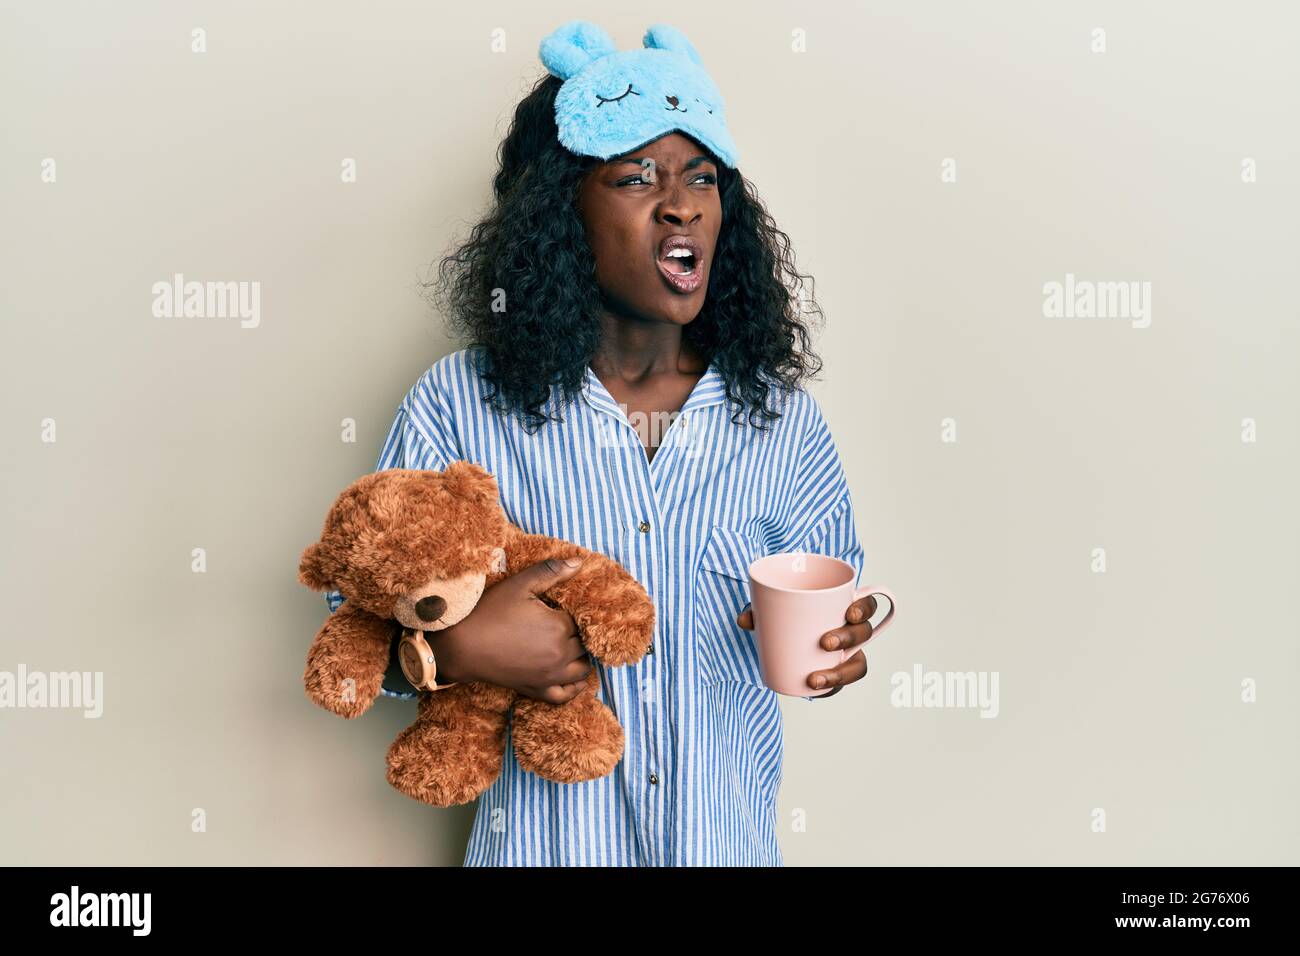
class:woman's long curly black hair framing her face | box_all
[421,73,823,431]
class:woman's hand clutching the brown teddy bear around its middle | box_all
[425,558,592,704]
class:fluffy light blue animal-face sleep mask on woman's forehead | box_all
[538,20,737,169]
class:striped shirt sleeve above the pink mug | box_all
[781,395,865,700]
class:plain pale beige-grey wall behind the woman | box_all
[0,3,1300,865]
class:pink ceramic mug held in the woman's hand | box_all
[749,551,896,697]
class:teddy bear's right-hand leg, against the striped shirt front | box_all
[511,667,623,783]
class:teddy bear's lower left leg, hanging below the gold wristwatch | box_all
[387,684,514,806]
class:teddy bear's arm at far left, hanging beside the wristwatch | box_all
[303,601,395,718]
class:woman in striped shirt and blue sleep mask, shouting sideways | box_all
[332,23,875,865]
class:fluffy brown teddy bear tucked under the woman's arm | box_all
[298,460,655,806]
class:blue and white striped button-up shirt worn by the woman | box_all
[328,350,863,866]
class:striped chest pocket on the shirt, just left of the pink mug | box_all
[694,524,764,687]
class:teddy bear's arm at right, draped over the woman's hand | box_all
[506,527,654,666]
